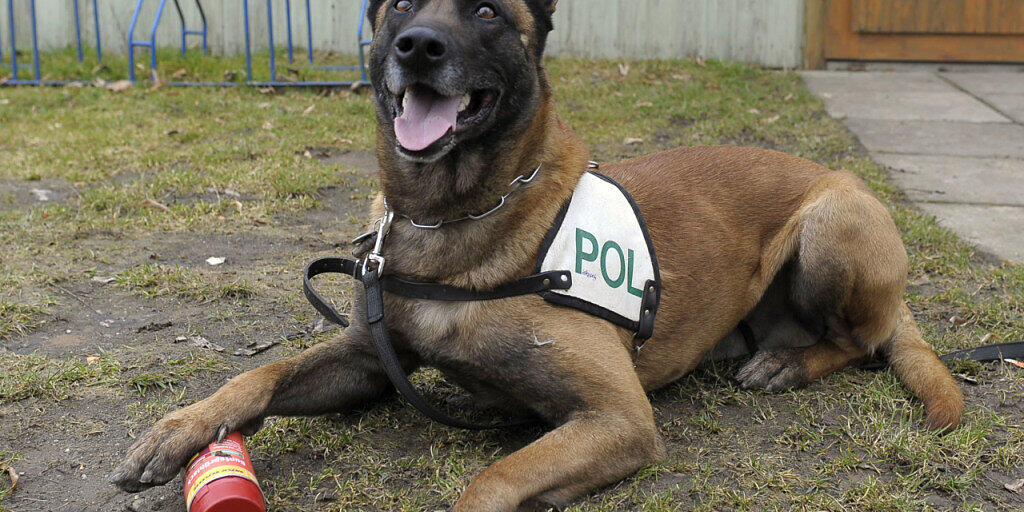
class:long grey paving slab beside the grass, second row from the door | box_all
[824,91,1007,123]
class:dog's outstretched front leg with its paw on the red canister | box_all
[110,328,399,493]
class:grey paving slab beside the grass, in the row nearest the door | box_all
[800,71,957,94]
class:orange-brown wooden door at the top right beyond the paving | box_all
[805,0,1024,67]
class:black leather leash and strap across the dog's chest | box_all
[302,258,572,430]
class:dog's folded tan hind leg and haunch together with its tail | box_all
[737,172,963,428]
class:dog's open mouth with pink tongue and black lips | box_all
[394,84,498,154]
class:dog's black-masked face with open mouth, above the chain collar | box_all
[367,0,557,163]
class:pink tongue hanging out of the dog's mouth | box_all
[394,87,462,152]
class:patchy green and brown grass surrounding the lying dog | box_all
[0,51,1024,512]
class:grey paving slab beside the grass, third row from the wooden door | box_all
[846,119,1024,159]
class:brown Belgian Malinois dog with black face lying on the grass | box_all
[112,0,963,512]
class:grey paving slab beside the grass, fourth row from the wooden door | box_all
[871,153,1024,207]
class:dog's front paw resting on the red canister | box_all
[109,406,222,493]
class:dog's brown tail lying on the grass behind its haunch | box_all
[888,304,964,432]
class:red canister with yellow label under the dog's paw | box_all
[185,432,266,512]
